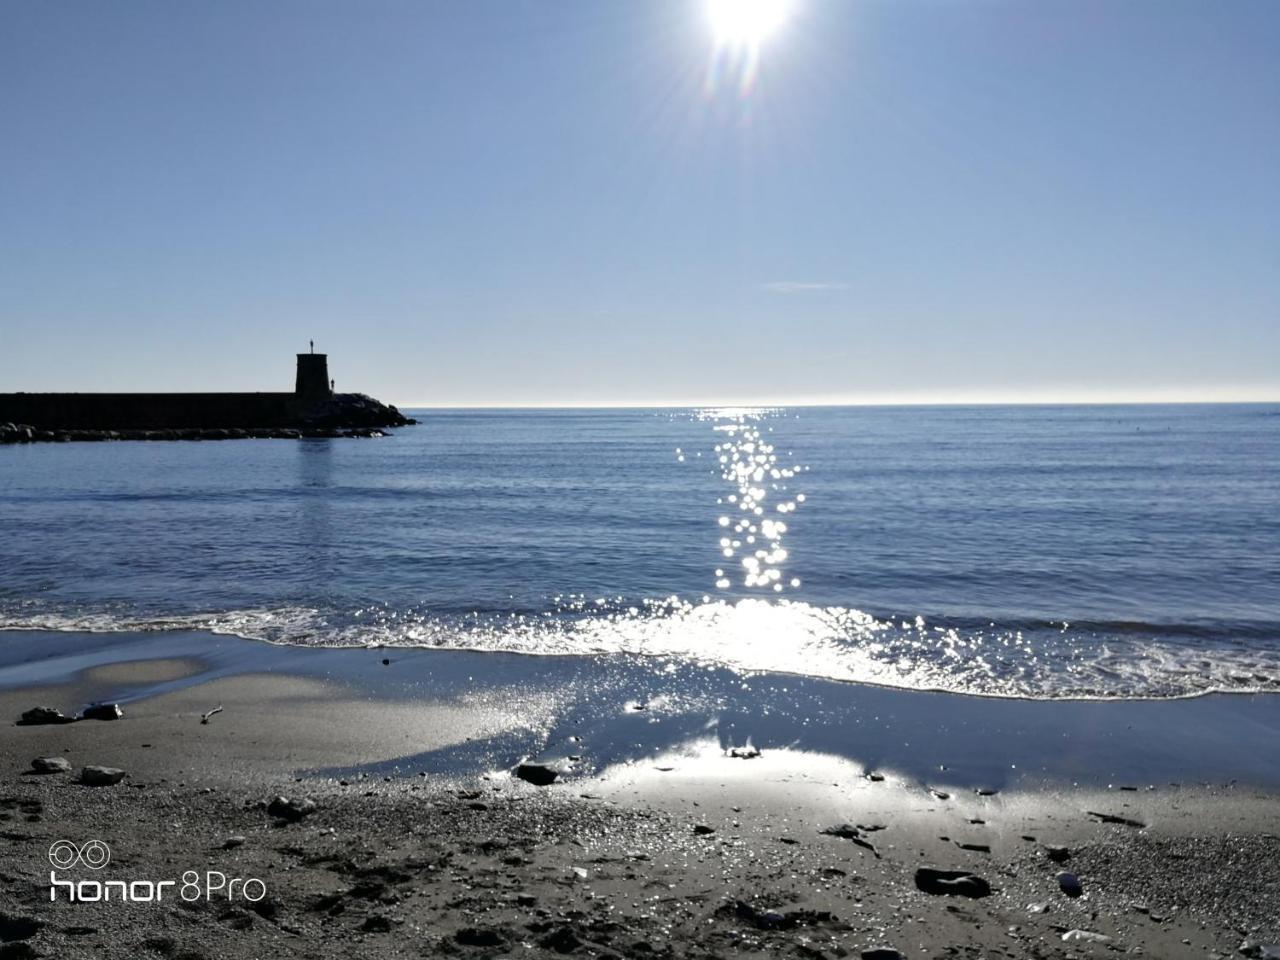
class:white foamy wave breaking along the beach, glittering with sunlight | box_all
[0,598,1280,699]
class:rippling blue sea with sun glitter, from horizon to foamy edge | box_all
[0,404,1280,698]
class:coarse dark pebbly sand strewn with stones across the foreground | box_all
[0,776,1280,960]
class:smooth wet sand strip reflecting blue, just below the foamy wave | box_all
[0,631,1280,790]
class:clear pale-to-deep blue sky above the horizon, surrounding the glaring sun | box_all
[0,0,1280,406]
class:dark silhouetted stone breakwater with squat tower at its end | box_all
[0,353,417,443]
